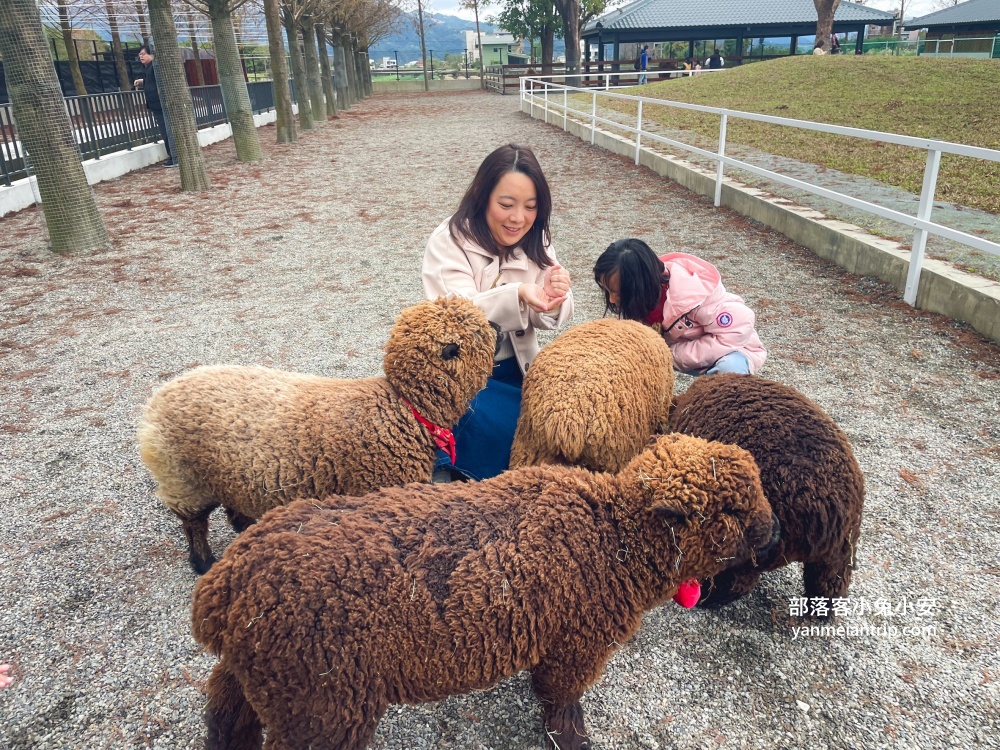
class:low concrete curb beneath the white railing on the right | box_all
[521,95,1000,343]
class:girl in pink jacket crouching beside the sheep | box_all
[594,239,767,375]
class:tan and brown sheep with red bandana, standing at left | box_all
[139,298,496,573]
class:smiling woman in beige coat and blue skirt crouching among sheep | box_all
[423,144,573,479]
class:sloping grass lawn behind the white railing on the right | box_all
[601,55,1000,214]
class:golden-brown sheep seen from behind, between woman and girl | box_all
[510,318,674,472]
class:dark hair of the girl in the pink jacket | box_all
[594,238,664,321]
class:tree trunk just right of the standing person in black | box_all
[149,0,211,192]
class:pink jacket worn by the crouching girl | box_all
[660,253,767,373]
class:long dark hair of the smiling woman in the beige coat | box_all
[448,143,552,268]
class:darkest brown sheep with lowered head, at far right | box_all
[668,375,865,606]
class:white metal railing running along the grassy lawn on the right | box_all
[521,74,1000,305]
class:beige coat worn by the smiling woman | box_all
[423,217,573,372]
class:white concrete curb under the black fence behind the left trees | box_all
[0,110,282,216]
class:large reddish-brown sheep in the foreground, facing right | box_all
[192,435,773,750]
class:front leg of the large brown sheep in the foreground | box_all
[531,659,592,750]
